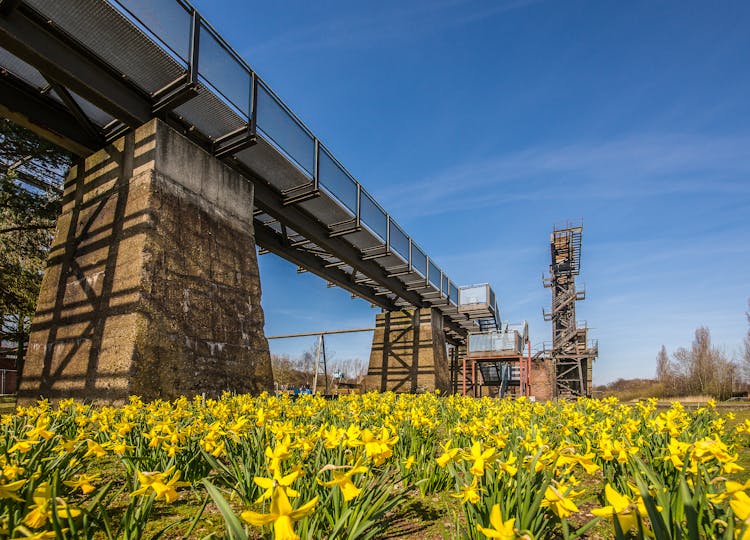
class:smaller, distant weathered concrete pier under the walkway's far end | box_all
[365,308,450,393]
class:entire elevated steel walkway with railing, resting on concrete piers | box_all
[0,0,506,343]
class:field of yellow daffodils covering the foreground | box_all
[0,393,750,540]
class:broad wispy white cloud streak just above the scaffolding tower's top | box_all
[380,134,750,216]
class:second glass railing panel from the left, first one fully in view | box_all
[198,25,251,117]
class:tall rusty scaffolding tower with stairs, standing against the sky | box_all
[543,226,599,399]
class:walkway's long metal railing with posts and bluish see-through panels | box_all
[107,0,464,306]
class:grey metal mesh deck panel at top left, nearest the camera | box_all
[28,0,184,93]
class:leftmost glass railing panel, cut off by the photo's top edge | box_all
[117,0,191,62]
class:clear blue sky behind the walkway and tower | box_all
[195,0,750,384]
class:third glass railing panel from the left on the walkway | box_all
[257,84,315,176]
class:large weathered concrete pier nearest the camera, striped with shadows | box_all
[19,120,273,402]
